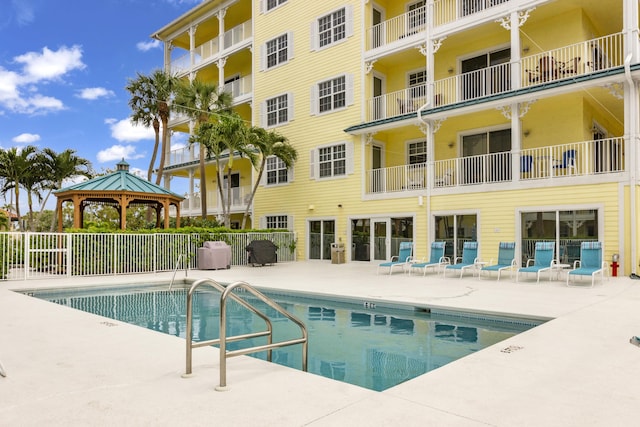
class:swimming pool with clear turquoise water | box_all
[27,285,541,391]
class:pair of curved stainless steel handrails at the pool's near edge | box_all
[184,279,309,391]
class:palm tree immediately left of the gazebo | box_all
[42,148,93,231]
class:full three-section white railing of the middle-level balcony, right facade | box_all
[366,33,624,122]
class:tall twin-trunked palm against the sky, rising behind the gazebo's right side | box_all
[126,69,178,185]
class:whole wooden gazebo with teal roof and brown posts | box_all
[54,159,184,232]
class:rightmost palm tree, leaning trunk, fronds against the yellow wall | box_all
[242,127,298,229]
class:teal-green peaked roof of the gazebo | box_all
[56,160,184,200]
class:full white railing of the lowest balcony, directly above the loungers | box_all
[365,138,625,194]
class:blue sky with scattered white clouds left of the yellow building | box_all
[0,0,201,209]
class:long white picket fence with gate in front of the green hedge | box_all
[0,232,296,280]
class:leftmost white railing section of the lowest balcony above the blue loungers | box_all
[366,163,427,194]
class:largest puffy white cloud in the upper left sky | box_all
[13,45,86,82]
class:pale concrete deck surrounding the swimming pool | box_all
[0,261,640,427]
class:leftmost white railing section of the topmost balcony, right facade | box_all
[366,6,427,50]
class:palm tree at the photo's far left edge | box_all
[0,145,37,229]
